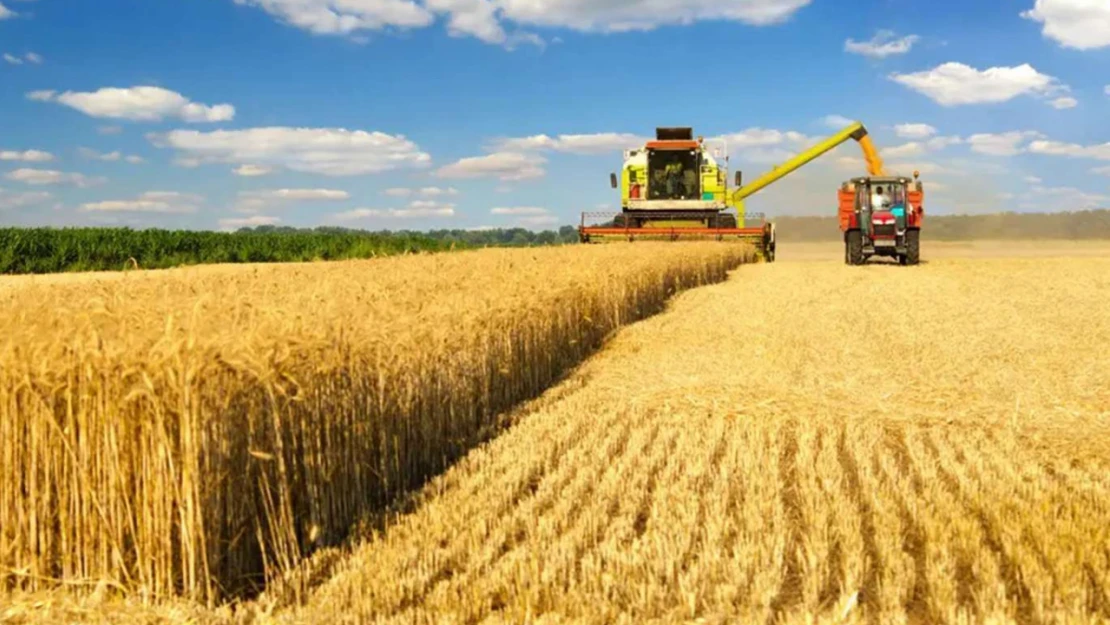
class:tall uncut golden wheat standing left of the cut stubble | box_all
[0,244,750,602]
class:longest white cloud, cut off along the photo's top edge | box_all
[235,0,811,47]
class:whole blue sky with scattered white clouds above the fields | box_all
[0,0,1110,229]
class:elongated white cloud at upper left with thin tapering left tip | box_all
[27,87,235,122]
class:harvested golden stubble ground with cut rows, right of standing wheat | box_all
[0,245,1110,625]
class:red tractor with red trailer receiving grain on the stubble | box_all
[838,171,925,264]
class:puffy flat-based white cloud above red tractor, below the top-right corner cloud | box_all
[889,62,1067,107]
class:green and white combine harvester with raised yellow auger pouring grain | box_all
[578,122,882,262]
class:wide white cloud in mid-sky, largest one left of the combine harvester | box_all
[154,127,432,177]
